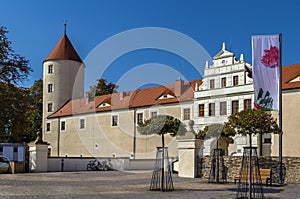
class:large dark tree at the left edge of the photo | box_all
[0,26,31,142]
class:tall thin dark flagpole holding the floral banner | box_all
[278,33,284,184]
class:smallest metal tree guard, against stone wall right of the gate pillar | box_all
[208,148,226,183]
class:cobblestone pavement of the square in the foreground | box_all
[0,171,300,199]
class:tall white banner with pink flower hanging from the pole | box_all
[252,35,280,110]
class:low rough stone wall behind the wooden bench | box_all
[198,156,300,183]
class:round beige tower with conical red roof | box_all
[43,27,85,140]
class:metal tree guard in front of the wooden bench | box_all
[236,147,264,199]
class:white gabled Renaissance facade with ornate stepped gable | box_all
[194,43,272,156]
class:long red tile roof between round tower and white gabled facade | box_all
[48,80,202,118]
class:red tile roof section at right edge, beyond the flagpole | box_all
[282,64,300,90]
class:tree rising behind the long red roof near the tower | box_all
[87,78,119,99]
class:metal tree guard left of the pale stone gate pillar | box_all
[150,147,174,191]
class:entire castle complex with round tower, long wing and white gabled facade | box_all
[43,28,300,159]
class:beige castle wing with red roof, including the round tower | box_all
[43,29,197,158]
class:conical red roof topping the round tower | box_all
[44,34,82,63]
